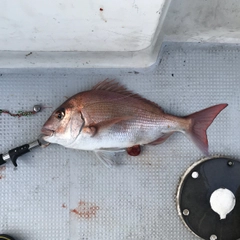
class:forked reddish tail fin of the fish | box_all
[185,104,228,155]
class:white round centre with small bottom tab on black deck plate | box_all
[210,188,236,220]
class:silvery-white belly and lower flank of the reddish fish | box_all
[66,118,178,150]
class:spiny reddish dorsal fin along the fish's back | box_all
[92,78,163,111]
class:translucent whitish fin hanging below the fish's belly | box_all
[94,150,124,168]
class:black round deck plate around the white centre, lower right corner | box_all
[177,157,240,240]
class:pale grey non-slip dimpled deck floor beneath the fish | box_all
[0,43,237,240]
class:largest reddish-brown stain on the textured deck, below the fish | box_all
[71,201,99,219]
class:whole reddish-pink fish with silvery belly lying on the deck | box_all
[41,79,228,167]
